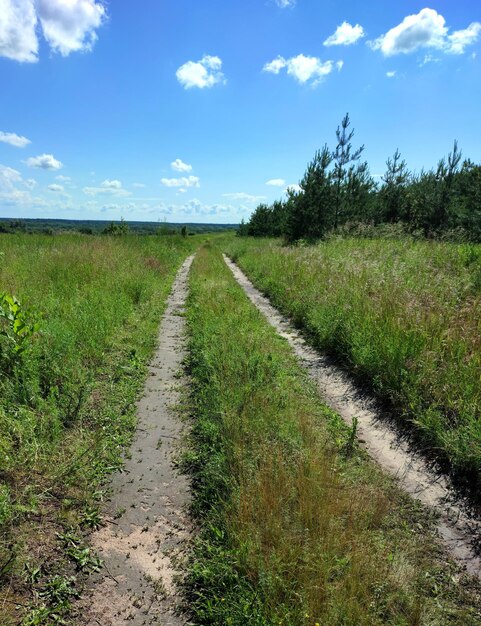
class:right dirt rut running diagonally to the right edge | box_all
[224,255,481,578]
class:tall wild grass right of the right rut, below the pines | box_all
[225,237,481,494]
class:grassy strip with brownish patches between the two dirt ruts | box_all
[185,245,481,626]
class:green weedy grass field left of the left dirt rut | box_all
[0,235,197,626]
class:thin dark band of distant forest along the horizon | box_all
[0,217,237,235]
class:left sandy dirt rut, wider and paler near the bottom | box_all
[79,257,193,626]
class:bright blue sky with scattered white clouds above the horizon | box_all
[0,0,481,223]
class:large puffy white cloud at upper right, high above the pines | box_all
[368,9,481,56]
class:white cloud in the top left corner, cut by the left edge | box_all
[0,0,38,63]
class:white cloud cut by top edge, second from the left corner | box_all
[37,0,106,56]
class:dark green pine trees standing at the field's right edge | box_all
[238,114,481,242]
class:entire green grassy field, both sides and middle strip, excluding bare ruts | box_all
[0,234,481,626]
